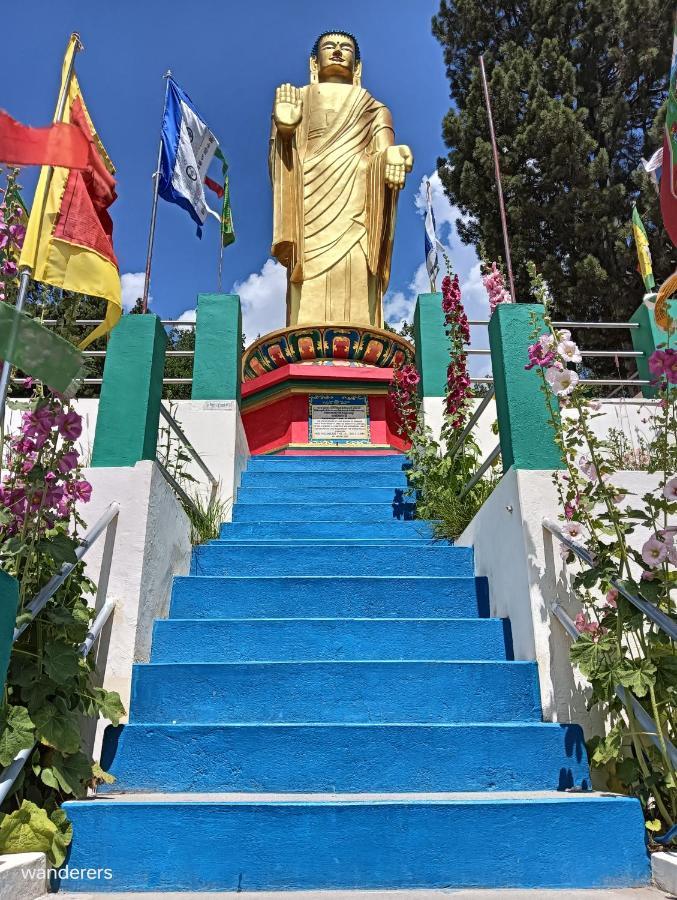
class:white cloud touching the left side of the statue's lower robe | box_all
[233,259,287,344]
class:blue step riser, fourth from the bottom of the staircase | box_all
[151,618,511,663]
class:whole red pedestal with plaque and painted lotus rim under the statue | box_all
[242,325,413,454]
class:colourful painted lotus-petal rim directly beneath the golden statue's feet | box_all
[242,325,414,381]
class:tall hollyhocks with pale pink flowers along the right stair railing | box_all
[525,292,677,833]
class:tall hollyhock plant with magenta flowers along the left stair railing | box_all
[0,396,124,864]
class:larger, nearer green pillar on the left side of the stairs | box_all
[92,313,167,466]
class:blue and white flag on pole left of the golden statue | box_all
[158,76,219,237]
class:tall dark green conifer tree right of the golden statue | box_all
[433,0,676,330]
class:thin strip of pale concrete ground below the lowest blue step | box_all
[51,887,672,900]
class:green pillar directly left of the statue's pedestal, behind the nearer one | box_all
[191,294,242,403]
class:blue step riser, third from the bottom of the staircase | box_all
[130,661,541,723]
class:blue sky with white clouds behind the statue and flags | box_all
[0,0,486,350]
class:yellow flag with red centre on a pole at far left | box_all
[19,35,122,348]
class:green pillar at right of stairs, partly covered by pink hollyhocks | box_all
[489,303,563,472]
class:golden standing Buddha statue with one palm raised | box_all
[270,32,413,328]
